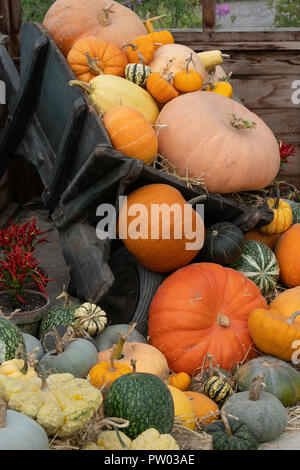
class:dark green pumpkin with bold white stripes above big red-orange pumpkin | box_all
[231,240,279,295]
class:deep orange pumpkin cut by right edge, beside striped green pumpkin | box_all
[275,224,300,287]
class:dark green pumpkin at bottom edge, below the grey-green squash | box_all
[203,418,258,450]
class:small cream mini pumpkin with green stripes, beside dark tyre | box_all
[73,302,107,336]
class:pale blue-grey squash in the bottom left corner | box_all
[0,410,49,450]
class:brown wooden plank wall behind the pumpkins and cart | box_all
[0,0,300,199]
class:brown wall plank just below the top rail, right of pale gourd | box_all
[224,50,300,77]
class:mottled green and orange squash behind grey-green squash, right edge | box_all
[234,356,300,406]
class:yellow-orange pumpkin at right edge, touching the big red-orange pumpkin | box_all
[248,308,300,361]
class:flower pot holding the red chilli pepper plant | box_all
[0,289,50,336]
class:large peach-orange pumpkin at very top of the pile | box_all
[43,0,147,57]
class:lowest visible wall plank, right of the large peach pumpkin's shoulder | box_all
[251,108,300,145]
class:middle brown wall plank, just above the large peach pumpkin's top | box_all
[231,75,300,109]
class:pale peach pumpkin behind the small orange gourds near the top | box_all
[148,44,207,83]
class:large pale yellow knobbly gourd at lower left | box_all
[0,374,103,437]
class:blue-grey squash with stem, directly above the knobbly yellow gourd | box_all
[36,338,98,378]
